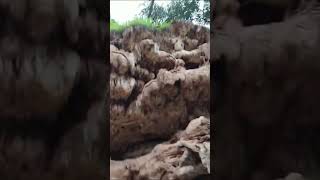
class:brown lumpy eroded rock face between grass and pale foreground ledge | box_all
[110,22,210,179]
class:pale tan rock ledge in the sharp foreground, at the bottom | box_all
[110,116,210,180]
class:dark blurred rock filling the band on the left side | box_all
[0,0,107,179]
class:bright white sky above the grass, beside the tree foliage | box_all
[110,0,169,23]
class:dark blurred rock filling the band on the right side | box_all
[211,1,320,180]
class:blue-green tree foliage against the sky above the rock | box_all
[140,0,210,24]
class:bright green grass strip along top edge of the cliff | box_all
[110,18,171,32]
